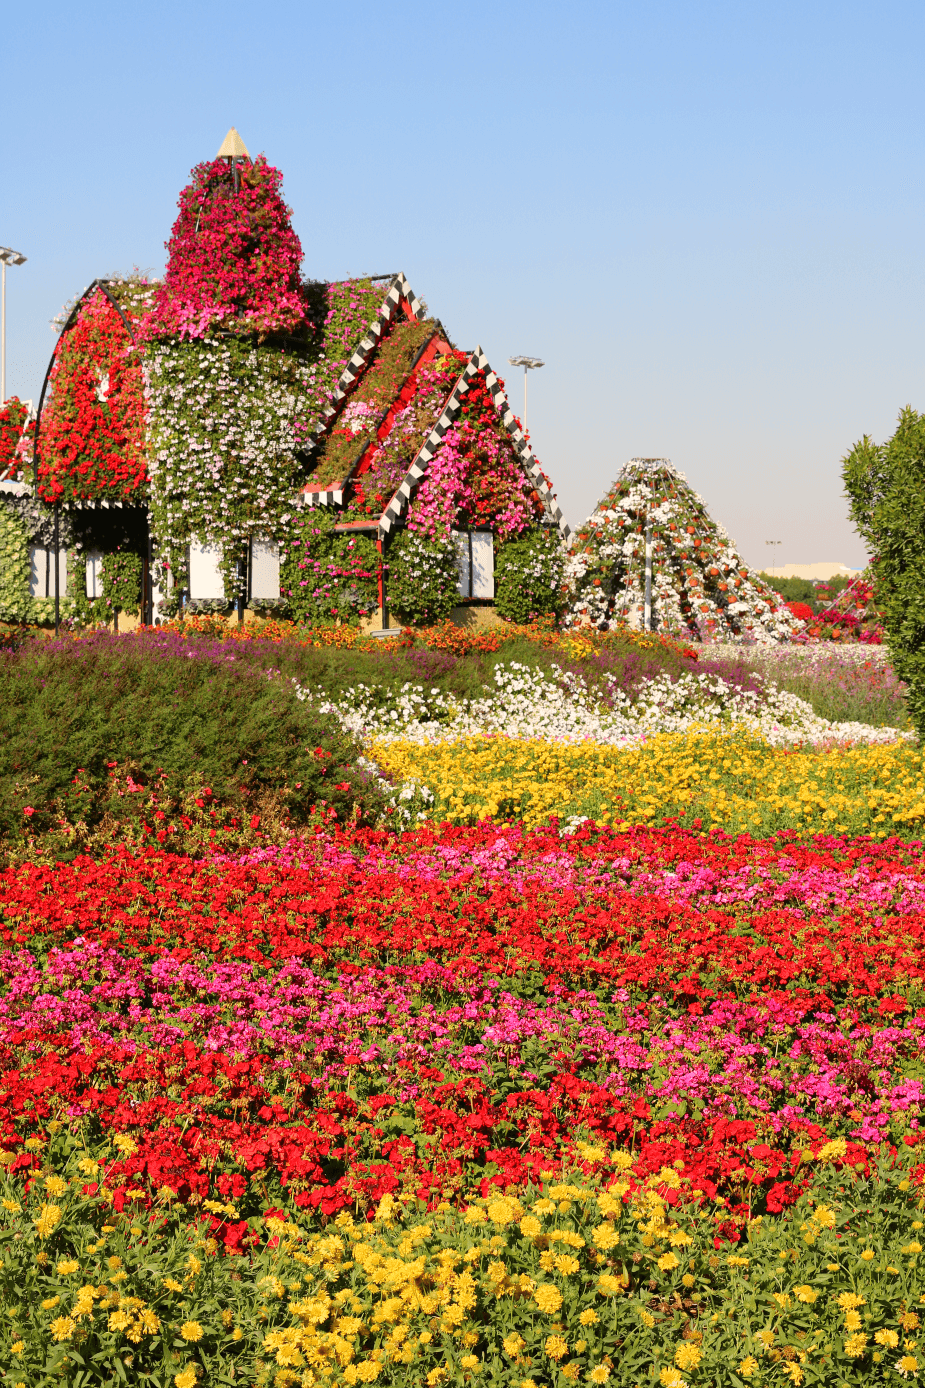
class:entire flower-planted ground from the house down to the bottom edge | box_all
[0,625,925,1388]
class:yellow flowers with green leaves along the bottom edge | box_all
[0,1138,925,1388]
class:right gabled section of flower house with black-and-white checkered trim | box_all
[290,275,568,620]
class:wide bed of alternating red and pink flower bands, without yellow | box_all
[0,827,925,1238]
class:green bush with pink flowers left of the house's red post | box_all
[279,507,379,626]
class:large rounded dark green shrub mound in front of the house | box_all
[0,633,378,847]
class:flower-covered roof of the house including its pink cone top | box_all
[35,130,567,545]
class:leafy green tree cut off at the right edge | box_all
[842,405,925,740]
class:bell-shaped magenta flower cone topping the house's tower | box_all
[144,144,304,339]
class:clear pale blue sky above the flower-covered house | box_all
[0,0,925,566]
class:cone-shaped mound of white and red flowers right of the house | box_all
[565,458,803,641]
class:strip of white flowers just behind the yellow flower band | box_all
[296,662,911,747]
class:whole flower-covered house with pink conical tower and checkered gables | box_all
[16,130,567,625]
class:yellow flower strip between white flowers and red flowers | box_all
[372,731,925,838]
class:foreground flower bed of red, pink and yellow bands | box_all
[0,826,925,1388]
